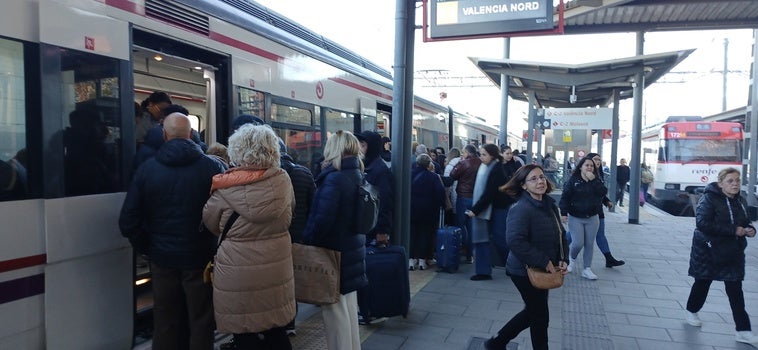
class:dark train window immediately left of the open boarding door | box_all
[53,49,122,196]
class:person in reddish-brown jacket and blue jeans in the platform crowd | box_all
[450,145,482,263]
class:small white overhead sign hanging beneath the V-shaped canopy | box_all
[545,108,613,129]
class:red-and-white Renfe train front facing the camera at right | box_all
[643,121,743,214]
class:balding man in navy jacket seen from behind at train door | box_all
[119,113,223,350]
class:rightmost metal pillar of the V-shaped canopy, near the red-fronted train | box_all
[629,32,645,224]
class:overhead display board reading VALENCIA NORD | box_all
[430,0,553,39]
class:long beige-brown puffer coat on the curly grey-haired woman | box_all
[203,168,295,333]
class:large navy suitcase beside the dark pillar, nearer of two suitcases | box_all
[358,246,411,319]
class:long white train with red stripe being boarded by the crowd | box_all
[0,0,504,349]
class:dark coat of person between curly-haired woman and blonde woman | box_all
[280,153,316,242]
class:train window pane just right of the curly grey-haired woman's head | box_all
[274,127,322,174]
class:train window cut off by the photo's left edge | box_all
[0,39,29,201]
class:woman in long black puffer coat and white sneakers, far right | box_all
[686,168,758,344]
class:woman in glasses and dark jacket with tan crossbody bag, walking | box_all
[485,164,568,350]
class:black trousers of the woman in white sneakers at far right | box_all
[687,279,751,332]
